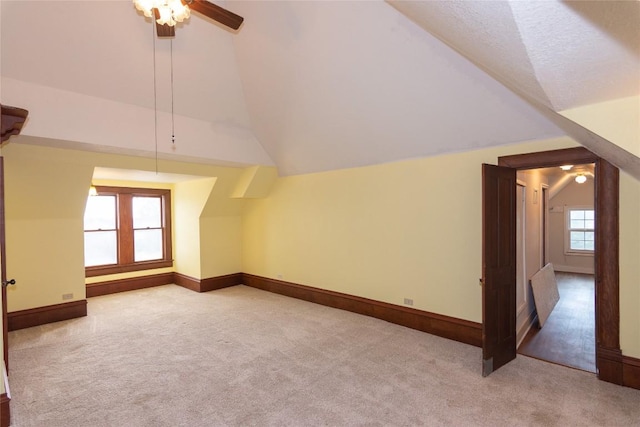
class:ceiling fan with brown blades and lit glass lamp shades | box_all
[133,0,244,37]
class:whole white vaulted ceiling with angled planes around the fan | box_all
[0,0,640,178]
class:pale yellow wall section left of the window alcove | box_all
[2,143,93,312]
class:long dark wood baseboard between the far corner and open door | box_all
[242,273,482,347]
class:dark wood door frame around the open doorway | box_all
[483,147,622,384]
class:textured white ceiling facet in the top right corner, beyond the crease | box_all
[510,1,640,111]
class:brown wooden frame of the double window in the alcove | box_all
[83,186,173,277]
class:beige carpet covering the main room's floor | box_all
[9,285,640,427]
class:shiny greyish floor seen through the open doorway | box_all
[518,273,596,372]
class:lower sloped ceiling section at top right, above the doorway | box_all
[388,0,640,179]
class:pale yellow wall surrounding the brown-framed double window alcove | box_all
[2,140,244,312]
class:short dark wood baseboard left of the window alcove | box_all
[7,299,87,331]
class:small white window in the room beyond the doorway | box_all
[565,206,595,255]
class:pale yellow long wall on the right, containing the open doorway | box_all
[242,139,640,357]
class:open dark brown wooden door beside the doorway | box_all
[482,164,516,376]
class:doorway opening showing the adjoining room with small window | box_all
[516,164,596,373]
